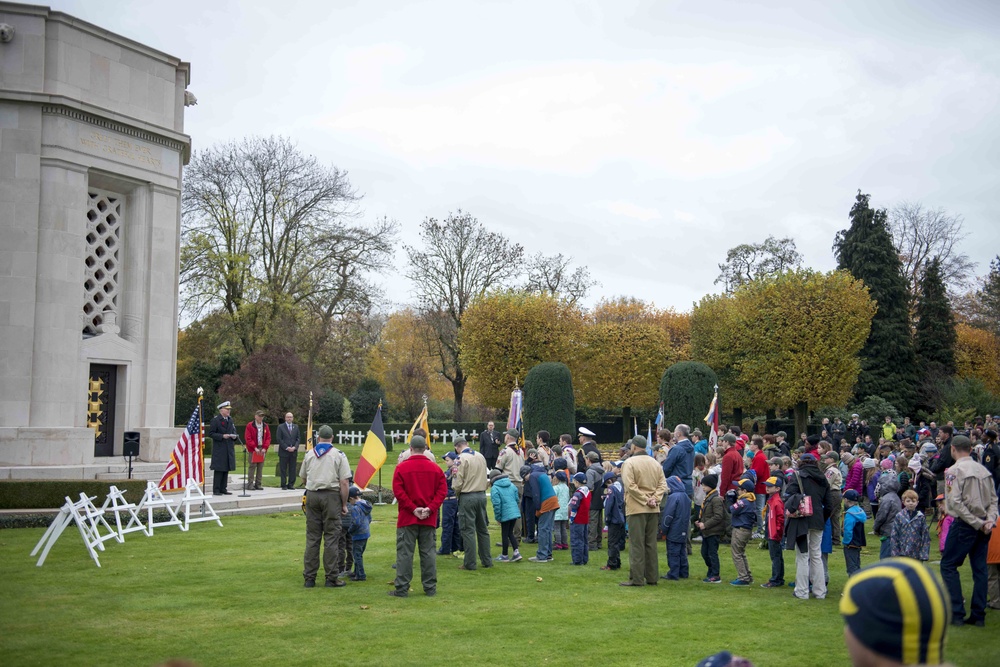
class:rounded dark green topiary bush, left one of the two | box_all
[523,361,576,444]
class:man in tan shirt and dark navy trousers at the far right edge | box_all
[941,435,997,627]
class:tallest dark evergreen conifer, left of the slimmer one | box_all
[833,190,916,414]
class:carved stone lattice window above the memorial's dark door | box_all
[83,190,124,336]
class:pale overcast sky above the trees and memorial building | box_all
[53,0,1000,310]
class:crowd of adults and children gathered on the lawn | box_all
[211,396,1000,666]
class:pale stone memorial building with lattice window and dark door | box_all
[0,2,193,477]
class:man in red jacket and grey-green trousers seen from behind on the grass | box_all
[389,435,448,598]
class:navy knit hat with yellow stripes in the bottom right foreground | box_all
[840,558,951,665]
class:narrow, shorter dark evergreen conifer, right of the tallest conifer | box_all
[913,257,958,409]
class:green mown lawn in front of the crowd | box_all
[0,448,1000,667]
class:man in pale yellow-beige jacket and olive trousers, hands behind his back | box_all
[618,435,667,586]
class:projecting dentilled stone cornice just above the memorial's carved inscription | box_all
[0,90,191,164]
